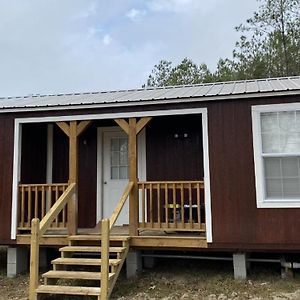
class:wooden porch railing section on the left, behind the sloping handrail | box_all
[18,183,68,230]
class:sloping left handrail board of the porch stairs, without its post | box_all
[40,183,76,236]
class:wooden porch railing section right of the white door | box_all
[138,181,205,231]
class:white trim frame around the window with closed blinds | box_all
[252,103,300,208]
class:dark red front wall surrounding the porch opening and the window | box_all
[0,96,300,250]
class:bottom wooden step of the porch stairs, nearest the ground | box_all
[36,285,101,296]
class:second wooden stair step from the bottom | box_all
[42,271,114,280]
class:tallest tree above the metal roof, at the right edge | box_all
[233,0,300,79]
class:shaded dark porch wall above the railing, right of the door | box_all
[146,115,203,181]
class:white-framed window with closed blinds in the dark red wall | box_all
[252,104,300,207]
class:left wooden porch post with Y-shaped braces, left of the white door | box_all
[56,121,91,235]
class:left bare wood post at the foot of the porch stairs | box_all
[29,219,40,300]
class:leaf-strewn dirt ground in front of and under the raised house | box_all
[0,248,300,300]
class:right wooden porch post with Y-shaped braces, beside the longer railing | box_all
[115,117,152,236]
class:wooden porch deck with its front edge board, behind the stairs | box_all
[17,225,207,249]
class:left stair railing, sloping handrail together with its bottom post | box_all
[29,183,76,300]
